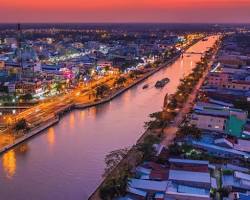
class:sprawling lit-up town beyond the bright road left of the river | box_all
[0,28,188,101]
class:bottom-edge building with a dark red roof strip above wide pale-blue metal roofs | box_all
[166,158,212,200]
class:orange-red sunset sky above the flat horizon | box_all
[0,0,250,23]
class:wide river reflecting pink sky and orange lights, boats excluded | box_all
[0,36,219,200]
